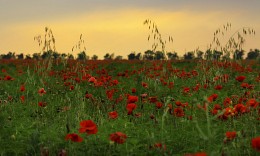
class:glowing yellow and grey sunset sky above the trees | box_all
[0,0,260,59]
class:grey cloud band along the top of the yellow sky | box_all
[0,0,260,23]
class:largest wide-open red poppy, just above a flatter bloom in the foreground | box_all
[79,120,98,135]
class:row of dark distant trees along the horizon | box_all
[0,49,260,60]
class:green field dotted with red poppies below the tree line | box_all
[0,59,260,156]
